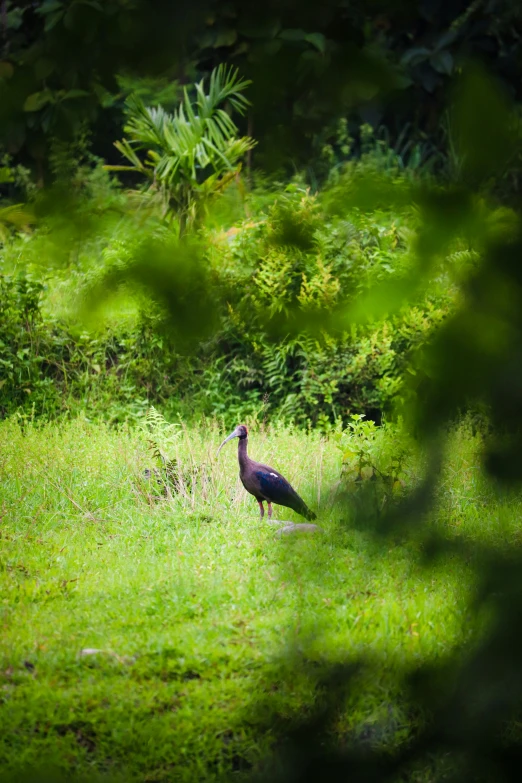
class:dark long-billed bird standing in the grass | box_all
[218,424,316,519]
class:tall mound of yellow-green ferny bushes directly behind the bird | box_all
[191,182,454,425]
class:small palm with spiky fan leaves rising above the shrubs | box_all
[106,65,255,235]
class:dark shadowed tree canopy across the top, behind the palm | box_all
[0,0,522,178]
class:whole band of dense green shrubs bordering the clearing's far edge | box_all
[0,177,451,426]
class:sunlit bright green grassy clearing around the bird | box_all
[0,420,520,781]
